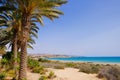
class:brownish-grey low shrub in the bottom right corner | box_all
[98,66,120,80]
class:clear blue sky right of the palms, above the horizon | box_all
[28,0,120,56]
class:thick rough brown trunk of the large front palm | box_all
[18,13,30,80]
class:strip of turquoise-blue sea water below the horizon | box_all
[48,57,120,63]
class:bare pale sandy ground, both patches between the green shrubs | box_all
[27,68,102,80]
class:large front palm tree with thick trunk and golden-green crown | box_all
[0,0,66,80]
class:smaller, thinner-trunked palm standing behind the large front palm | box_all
[0,8,39,78]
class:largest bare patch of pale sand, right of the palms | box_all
[50,68,102,80]
